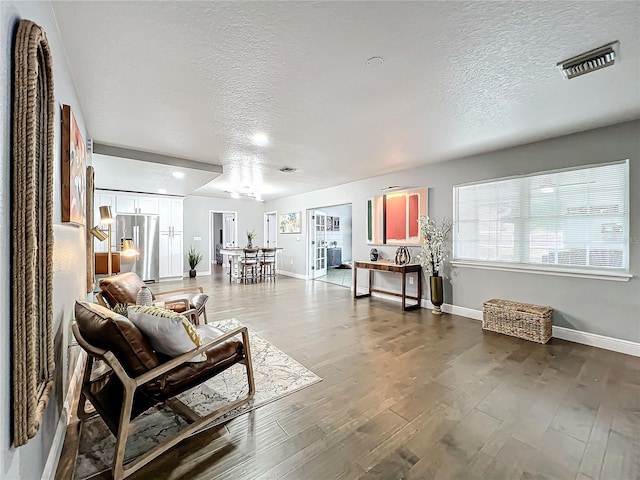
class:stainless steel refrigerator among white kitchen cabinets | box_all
[114,215,160,282]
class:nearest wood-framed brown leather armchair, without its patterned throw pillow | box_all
[72,302,255,480]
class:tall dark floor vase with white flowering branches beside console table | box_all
[417,215,452,315]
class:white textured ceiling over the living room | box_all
[53,1,640,199]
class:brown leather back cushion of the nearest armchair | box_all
[75,302,159,377]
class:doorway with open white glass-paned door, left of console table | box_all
[307,203,353,288]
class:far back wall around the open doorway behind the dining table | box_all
[184,195,265,273]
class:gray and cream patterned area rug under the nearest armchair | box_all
[74,318,322,480]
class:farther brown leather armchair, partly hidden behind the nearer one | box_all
[96,272,209,324]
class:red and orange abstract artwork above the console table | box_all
[367,188,428,245]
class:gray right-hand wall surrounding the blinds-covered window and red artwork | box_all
[265,121,640,342]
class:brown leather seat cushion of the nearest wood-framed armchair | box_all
[142,324,244,401]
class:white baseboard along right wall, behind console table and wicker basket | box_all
[358,288,640,357]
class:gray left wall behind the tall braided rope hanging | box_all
[0,0,87,480]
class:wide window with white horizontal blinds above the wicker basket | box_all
[453,160,629,272]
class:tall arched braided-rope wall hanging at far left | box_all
[11,20,55,447]
